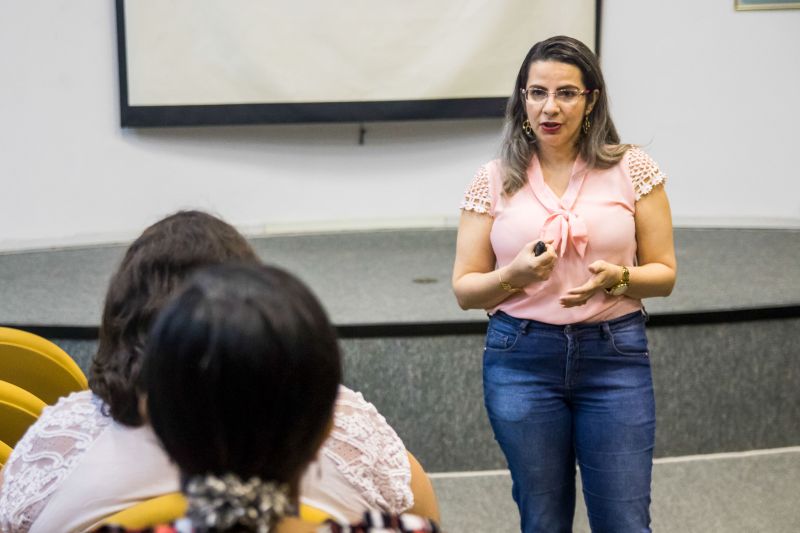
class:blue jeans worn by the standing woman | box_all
[483,312,655,533]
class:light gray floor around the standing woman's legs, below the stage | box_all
[432,447,800,533]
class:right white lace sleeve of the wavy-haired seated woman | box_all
[322,386,414,513]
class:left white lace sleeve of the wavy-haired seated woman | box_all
[0,391,111,533]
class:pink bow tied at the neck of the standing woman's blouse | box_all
[528,157,589,257]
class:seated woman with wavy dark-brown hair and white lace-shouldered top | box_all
[0,211,438,533]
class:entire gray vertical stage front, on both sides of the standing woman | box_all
[55,319,800,472]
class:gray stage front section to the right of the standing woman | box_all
[649,319,800,456]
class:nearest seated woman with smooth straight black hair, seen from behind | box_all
[100,265,437,533]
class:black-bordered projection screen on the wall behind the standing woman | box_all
[116,0,600,127]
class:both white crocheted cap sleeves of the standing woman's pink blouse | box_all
[460,146,667,214]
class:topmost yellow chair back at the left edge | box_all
[0,328,89,404]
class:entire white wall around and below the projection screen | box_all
[0,0,800,250]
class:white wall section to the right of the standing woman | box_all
[601,0,800,226]
